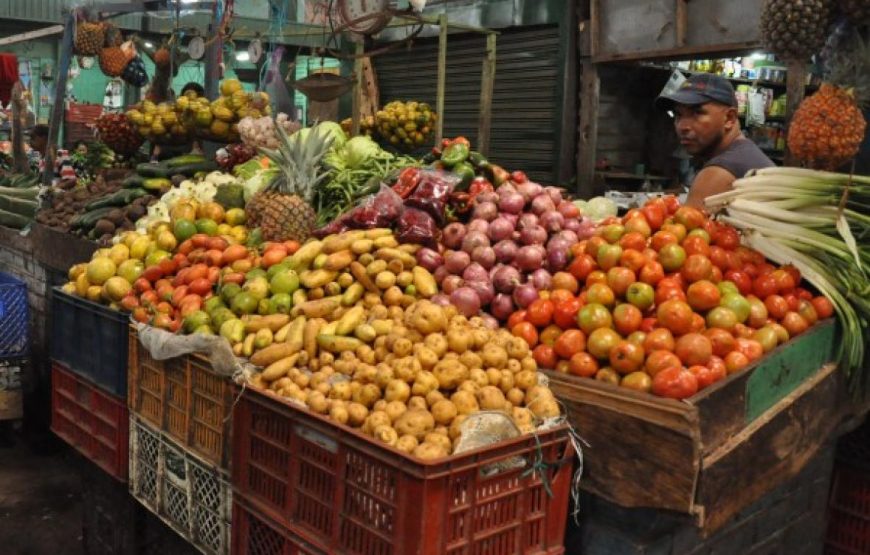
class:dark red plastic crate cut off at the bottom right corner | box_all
[825,464,870,555]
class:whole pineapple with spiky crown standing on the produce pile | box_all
[246,126,333,242]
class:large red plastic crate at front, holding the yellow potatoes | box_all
[232,388,573,555]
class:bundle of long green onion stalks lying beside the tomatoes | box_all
[705,167,870,399]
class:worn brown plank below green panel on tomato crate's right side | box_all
[698,364,849,535]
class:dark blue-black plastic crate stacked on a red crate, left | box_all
[51,287,130,399]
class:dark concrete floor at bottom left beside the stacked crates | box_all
[0,422,84,555]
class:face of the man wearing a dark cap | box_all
[674,102,737,156]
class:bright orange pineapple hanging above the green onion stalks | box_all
[788,37,870,170]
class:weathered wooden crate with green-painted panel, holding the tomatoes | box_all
[548,320,849,533]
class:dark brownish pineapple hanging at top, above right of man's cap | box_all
[761,0,833,61]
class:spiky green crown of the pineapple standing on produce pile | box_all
[259,125,335,203]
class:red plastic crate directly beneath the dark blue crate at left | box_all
[51,361,130,482]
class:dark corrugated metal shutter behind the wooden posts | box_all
[374,25,560,182]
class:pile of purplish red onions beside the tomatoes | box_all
[417,181,594,320]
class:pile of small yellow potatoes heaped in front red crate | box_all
[251,300,560,459]
